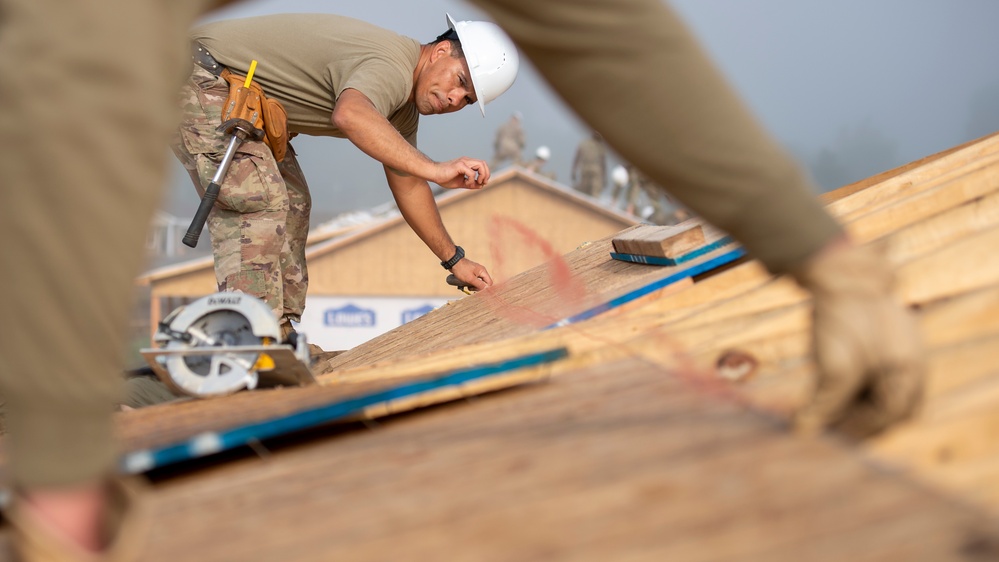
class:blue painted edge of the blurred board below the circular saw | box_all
[121,347,568,474]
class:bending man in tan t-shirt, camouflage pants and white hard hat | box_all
[174,14,518,344]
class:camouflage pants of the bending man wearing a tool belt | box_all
[173,66,312,321]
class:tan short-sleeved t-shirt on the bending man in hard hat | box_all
[191,14,420,146]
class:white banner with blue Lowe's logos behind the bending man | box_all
[298,295,451,351]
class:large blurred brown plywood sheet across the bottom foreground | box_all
[76,360,999,562]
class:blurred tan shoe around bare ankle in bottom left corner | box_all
[5,479,151,562]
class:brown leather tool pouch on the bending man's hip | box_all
[222,68,288,162]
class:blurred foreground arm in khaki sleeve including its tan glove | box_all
[473,0,925,436]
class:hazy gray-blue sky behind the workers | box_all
[160,0,999,218]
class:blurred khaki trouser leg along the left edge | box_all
[0,0,207,488]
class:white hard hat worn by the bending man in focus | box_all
[445,14,520,117]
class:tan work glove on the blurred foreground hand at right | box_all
[793,240,926,438]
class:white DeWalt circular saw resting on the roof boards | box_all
[141,293,315,398]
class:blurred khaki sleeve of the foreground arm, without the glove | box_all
[473,0,841,272]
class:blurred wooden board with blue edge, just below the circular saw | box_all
[117,349,567,473]
